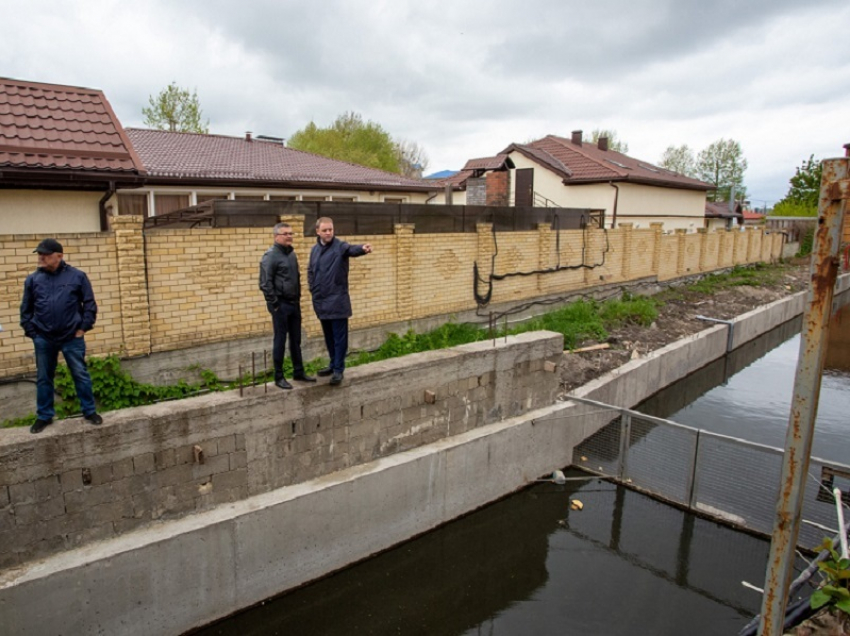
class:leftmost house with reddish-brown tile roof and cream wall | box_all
[0,78,144,234]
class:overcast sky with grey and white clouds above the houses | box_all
[6,0,850,206]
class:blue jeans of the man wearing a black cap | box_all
[33,336,97,420]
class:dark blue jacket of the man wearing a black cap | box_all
[21,261,97,343]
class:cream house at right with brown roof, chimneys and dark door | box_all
[441,130,714,231]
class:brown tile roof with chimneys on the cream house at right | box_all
[502,135,714,190]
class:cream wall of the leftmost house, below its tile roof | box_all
[0,190,103,235]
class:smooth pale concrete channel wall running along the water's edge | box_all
[0,276,850,636]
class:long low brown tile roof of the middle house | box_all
[127,128,438,191]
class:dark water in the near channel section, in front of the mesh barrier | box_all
[198,473,768,636]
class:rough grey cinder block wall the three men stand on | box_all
[0,332,563,569]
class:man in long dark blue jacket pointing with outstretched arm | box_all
[307,217,372,384]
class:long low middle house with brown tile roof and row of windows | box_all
[118,128,439,216]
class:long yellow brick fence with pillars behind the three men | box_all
[0,215,782,378]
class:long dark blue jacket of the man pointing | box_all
[307,237,366,320]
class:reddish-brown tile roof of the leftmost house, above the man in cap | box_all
[0,78,142,183]
